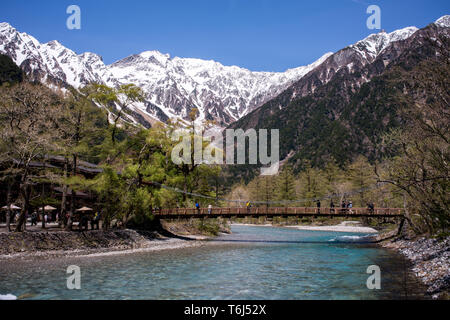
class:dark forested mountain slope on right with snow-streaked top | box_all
[230,16,450,180]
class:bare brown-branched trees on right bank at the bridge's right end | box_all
[377,60,450,234]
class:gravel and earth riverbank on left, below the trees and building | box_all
[0,230,205,261]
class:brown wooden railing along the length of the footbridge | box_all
[155,207,404,216]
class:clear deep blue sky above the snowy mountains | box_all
[0,0,450,71]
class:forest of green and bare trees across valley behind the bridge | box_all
[0,57,450,234]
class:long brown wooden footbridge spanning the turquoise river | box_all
[155,207,404,219]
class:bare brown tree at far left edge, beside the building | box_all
[0,83,61,231]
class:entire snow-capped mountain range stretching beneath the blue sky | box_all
[0,16,450,125]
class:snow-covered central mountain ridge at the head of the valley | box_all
[106,51,330,123]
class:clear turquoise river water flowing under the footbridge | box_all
[0,226,423,300]
